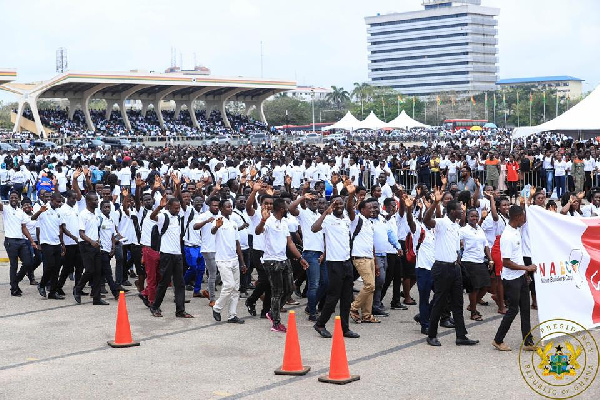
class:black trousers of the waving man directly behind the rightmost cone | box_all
[316,260,354,332]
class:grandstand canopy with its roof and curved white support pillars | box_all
[0,71,296,139]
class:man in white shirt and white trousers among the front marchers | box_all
[210,199,246,324]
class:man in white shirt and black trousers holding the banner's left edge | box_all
[492,206,537,351]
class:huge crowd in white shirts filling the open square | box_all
[0,133,600,351]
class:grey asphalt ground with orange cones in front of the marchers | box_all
[0,263,600,400]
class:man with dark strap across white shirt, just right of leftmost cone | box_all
[150,196,193,318]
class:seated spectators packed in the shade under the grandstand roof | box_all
[18,108,268,138]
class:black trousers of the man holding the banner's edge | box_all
[494,274,533,344]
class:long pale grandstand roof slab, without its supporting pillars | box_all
[0,71,296,101]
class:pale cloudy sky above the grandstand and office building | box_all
[0,0,600,100]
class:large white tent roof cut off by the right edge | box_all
[512,86,600,139]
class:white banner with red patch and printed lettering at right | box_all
[527,206,600,329]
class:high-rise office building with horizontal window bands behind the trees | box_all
[365,0,500,96]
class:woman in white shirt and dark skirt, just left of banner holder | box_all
[459,208,494,321]
